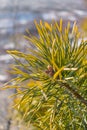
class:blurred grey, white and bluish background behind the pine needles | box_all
[0,0,87,130]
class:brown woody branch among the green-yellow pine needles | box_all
[62,83,87,106]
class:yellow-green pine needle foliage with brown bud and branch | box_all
[7,20,87,130]
